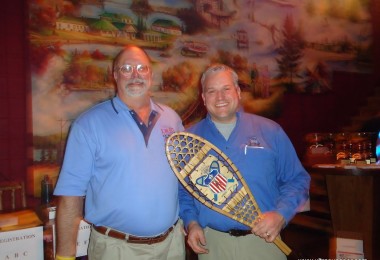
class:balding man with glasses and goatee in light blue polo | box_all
[54,46,185,260]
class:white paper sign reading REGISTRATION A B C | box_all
[0,226,44,260]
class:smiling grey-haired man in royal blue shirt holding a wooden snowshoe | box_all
[179,64,310,260]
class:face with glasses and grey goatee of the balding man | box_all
[114,48,152,100]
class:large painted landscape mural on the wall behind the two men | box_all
[28,0,372,195]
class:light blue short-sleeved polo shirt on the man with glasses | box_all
[54,97,183,236]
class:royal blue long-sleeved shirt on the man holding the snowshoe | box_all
[180,111,310,231]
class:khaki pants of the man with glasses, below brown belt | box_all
[88,221,185,260]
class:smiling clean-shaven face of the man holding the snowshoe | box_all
[202,71,240,123]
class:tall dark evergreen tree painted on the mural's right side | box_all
[276,15,305,91]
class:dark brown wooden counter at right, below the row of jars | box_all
[306,164,380,260]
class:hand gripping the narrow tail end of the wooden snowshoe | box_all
[252,211,285,242]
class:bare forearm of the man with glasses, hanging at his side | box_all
[56,196,83,256]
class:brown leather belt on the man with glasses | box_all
[92,222,177,245]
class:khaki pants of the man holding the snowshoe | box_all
[198,228,287,260]
